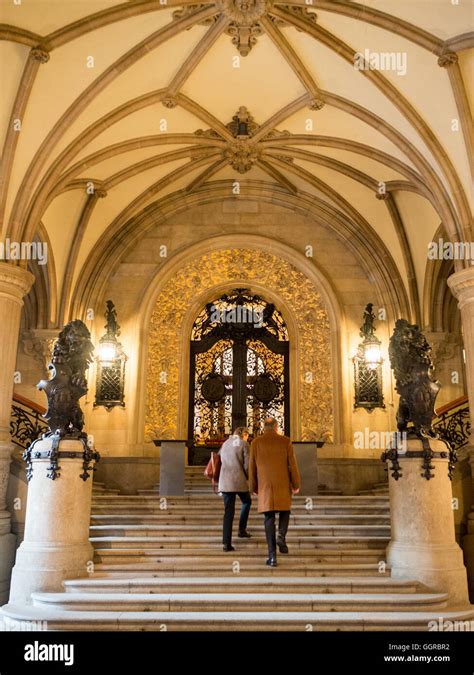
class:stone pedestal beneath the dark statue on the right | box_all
[387,440,469,605]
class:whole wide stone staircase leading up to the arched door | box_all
[4,467,474,631]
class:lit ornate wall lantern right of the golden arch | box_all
[352,303,385,412]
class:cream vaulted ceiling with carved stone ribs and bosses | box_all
[0,0,474,324]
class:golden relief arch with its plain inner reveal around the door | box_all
[145,247,338,441]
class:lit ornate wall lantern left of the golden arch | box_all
[94,300,127,410]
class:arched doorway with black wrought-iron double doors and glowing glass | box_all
[188,288,290,452]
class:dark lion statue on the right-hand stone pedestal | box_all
[389,319,441,438]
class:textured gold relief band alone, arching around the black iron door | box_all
[145,248,333,440]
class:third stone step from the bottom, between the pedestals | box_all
[64,575,420,594]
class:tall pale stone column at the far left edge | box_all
[0,262,34,604]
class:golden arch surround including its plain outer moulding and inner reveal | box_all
[137,234,344,444]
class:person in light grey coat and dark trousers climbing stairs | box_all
[218,427,252,551]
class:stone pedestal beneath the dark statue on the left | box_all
[10,439,94,604]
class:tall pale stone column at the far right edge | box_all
[448,267,474,601]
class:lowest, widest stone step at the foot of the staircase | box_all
[3,603,474,632]
